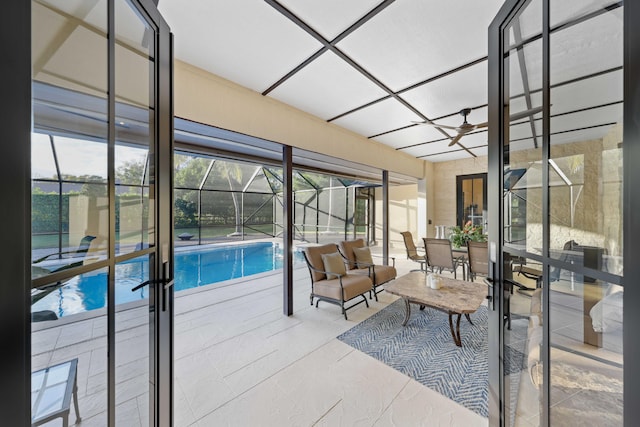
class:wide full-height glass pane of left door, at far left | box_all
[31,0,110,426]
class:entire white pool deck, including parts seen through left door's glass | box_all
[32,251,488,427]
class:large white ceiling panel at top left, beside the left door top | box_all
[159,0,322,92]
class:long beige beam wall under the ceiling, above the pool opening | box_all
[174,61,424,178]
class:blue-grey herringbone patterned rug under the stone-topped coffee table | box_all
[338,300,526,417]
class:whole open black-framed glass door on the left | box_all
[13,0,173,426]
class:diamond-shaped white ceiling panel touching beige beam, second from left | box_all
[269,52,386,120]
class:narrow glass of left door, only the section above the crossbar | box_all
[115,1,155,254]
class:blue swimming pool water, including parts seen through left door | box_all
[32,242,302,317]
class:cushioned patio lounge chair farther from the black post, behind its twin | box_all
[339,239,398,301]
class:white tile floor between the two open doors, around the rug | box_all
[175,256,488,427]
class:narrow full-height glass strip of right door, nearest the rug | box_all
[502,0,544,426]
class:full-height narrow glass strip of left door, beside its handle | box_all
[114,0,156,426]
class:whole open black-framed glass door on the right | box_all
[488,0,640,426]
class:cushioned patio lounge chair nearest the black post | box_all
[302,243,373,320]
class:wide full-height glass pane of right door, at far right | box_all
[548,0,623,425]
